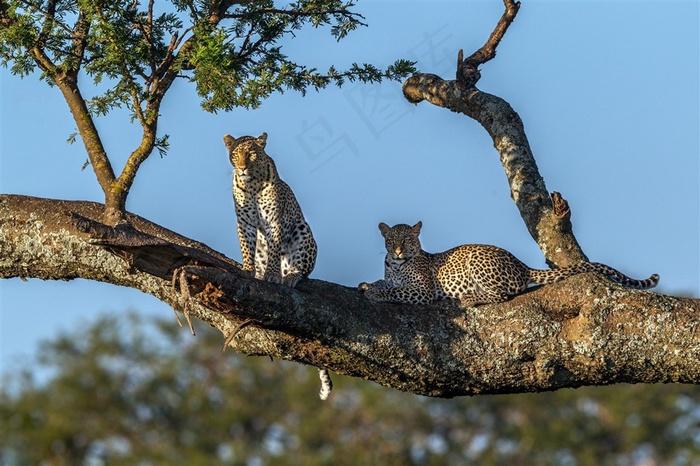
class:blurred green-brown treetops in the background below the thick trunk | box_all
[0,315,700,465]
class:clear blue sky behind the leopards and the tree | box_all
[0,1,700,370]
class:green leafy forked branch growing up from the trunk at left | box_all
[0,0,415,224]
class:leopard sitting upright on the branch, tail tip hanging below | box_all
[224,133,333,400]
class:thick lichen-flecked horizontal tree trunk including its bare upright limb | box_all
[0,0,700,397]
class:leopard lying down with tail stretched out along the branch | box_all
[359,222,659,307]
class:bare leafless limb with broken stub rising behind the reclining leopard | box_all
[403,0,587,266]
